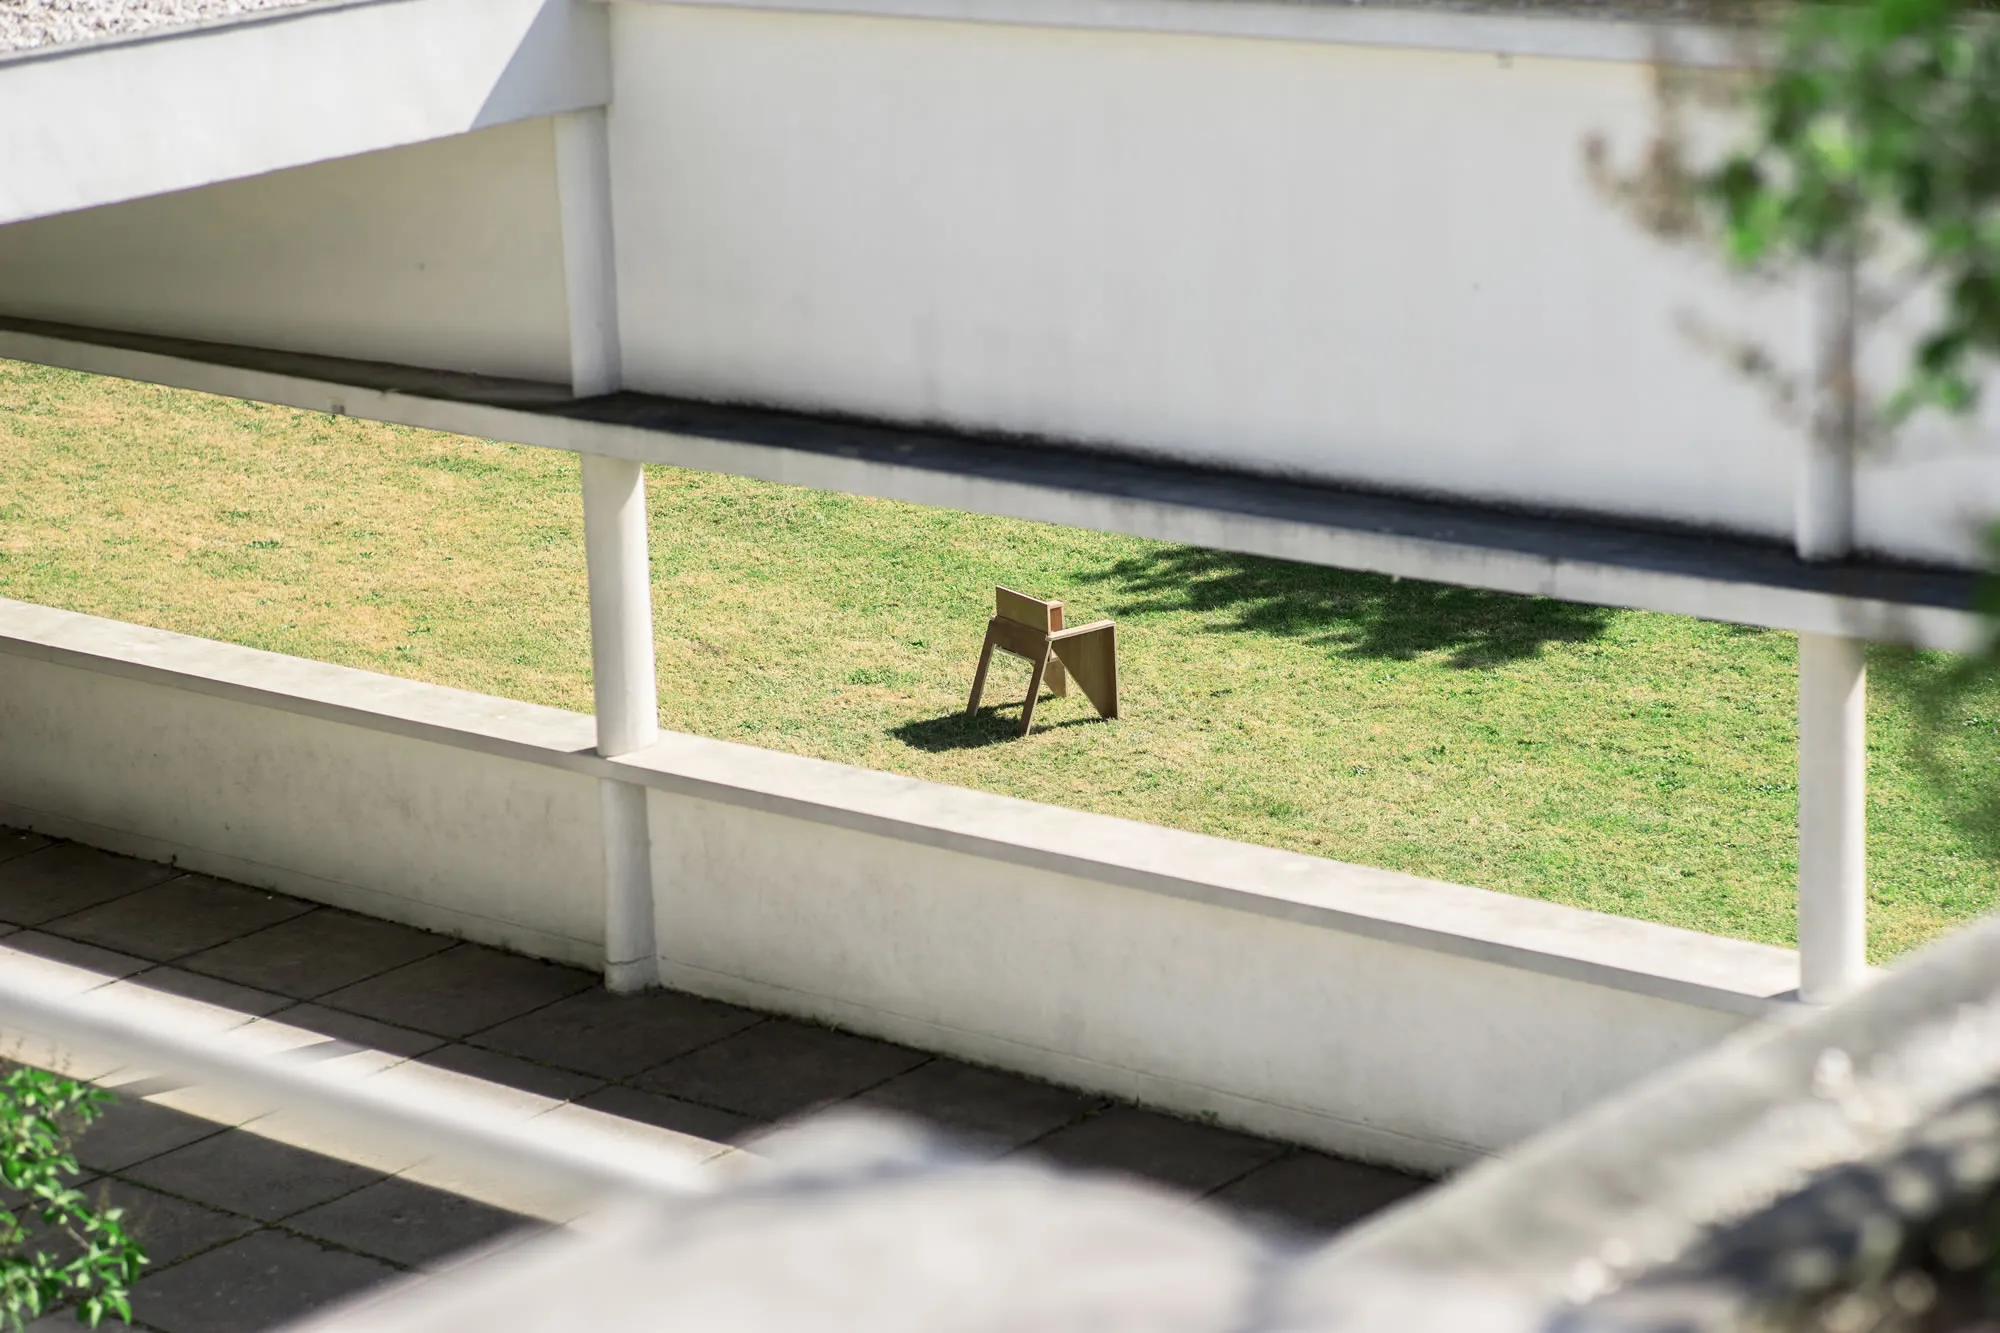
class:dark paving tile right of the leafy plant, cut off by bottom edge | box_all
[132,1231,396,1333]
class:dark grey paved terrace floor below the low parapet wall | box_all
[0,829,1424,1333]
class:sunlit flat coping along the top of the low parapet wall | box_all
[0,598,1796,1017]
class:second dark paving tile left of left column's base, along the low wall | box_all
[180,907,454,999]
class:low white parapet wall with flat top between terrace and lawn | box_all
[0,600,1798,1169]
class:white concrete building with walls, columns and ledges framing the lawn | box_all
[0,0,2000,1169]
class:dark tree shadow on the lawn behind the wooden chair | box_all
[1082,546,1614,671]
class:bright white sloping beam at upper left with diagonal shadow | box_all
[0,0,610,224]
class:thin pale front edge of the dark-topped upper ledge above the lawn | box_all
[0,324,1988,652]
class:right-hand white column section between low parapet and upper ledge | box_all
[1798,634,1868,1005]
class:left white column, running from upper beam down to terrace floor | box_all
[556,110,660,991]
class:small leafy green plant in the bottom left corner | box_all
[0,1069,146,1333]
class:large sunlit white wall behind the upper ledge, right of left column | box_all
[612,4,1832,542]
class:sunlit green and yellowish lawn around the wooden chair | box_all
[0,352,2000,959]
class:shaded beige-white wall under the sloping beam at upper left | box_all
[0,120,570,382]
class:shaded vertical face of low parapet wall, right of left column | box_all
[652,793,1744,1169]
